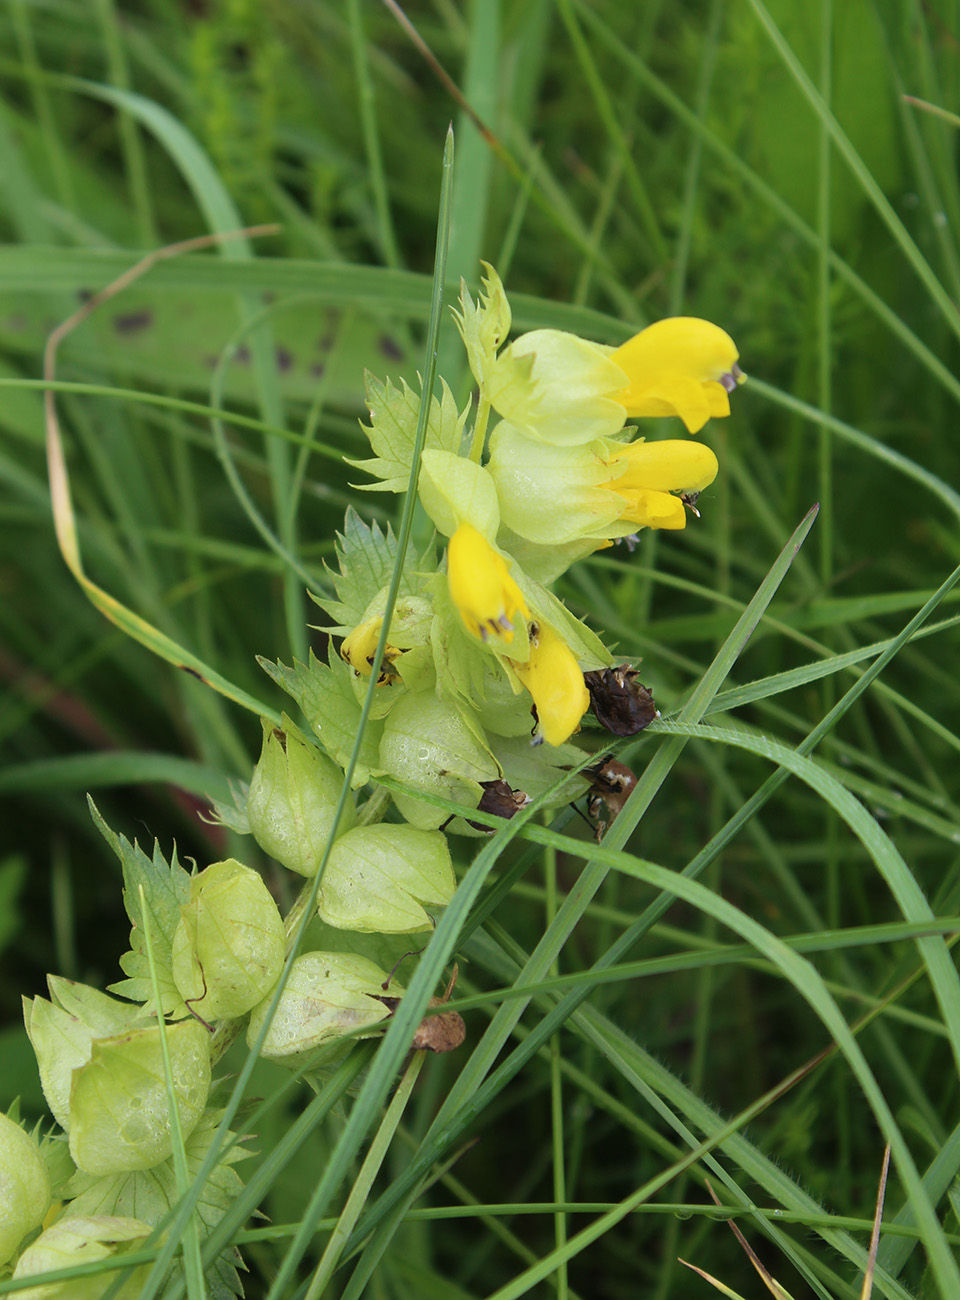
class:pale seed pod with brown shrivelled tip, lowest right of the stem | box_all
[247,953,402,1069]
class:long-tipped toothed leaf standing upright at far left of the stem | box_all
[88,800,190,1019]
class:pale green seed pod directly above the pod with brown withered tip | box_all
[317,822,457,935]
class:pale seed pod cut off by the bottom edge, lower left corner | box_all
[13,1214,153,1300]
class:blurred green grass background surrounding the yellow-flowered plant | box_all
[0,0,960,1300]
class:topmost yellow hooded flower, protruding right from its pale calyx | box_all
[610,316,747,434]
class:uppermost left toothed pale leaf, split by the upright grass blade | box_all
[345,372,470,491]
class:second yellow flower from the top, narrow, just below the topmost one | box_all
[601,438,719,528]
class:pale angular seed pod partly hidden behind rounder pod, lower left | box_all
[23,975,148,1132]
